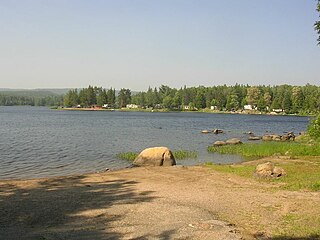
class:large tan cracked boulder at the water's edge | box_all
[133,147,176,166]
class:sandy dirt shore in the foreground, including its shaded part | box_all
[0,166,320,240]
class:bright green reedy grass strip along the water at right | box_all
[208,142,320,159]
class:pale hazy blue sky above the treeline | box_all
[0,0,320,90]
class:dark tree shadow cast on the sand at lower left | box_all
[0,176,173,240]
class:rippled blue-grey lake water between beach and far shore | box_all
[0,107,309,179]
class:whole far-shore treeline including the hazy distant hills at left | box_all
[0,84,320,115]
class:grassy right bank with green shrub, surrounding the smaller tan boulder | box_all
[206,115,320,191]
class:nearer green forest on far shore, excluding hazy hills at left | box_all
[64,84,320,114]
